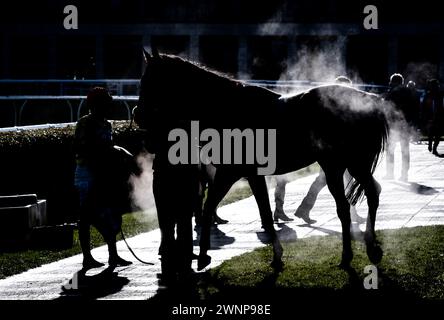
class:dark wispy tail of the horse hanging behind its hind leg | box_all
[346,98,389,205]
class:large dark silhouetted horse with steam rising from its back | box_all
[136,49,388,270]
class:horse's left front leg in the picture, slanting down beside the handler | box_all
[197,167,240,271]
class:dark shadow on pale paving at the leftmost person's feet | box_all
[58,267,130,300]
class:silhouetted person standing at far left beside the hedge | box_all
[74,87,131,269]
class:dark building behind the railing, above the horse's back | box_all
[0,0,444,125]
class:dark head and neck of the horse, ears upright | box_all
[135,47,238,128]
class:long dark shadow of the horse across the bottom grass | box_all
[144,268,437,319]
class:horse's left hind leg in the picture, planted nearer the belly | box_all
[321,164,353,268]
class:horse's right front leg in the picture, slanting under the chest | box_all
[248,176,283,271]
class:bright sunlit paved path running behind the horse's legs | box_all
[0,144,444,300]
